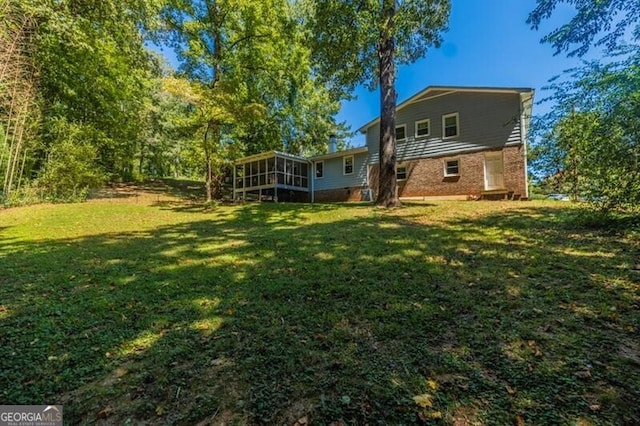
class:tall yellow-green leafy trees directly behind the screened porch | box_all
[159,0,344,197]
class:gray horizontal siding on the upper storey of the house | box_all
[367,92,521,164]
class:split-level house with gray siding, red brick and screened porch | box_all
[234,86,534,202]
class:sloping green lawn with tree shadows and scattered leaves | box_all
[0,181,640,425]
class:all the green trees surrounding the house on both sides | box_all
[0,0,640,211]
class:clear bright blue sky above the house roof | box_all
[337,0,596,146]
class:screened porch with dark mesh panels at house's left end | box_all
[233,151,310,201]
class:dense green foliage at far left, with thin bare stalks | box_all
[0,0,159,203]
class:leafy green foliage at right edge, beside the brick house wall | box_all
[533,47,640,211]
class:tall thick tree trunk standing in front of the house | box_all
[376,0,400,207]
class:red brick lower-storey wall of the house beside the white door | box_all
[369,146,527,198]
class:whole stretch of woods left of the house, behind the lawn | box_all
[0,0,345,204]
